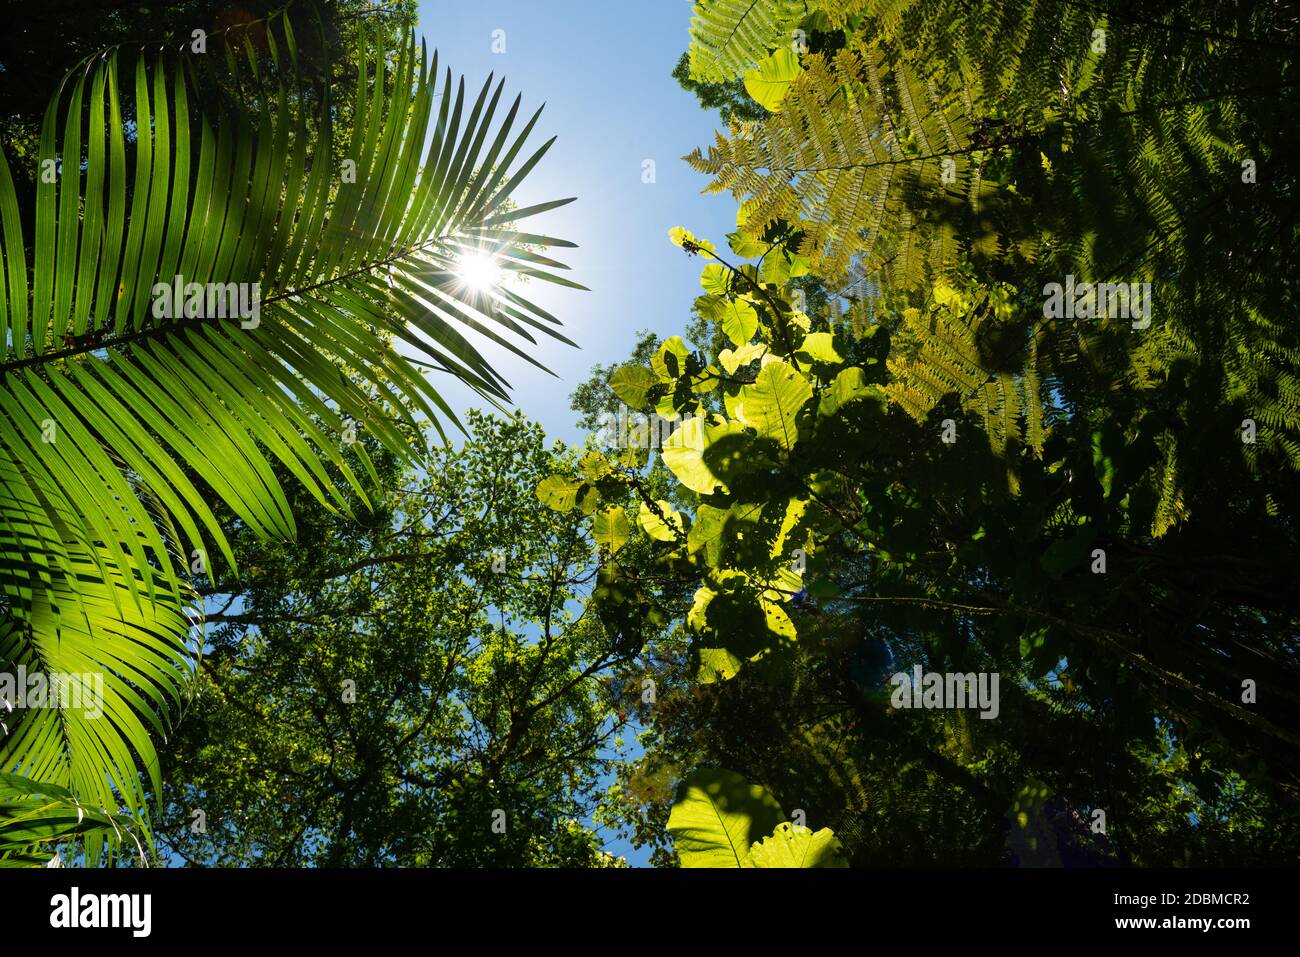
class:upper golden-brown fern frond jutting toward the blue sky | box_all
[686,47,979,289]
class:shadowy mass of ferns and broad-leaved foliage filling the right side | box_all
[559,0,1300,865]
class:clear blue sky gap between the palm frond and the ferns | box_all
[420,0,736,441]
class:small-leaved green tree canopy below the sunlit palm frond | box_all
[157,415,623,866]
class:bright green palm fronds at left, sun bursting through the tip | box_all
[0,9,576,858]
